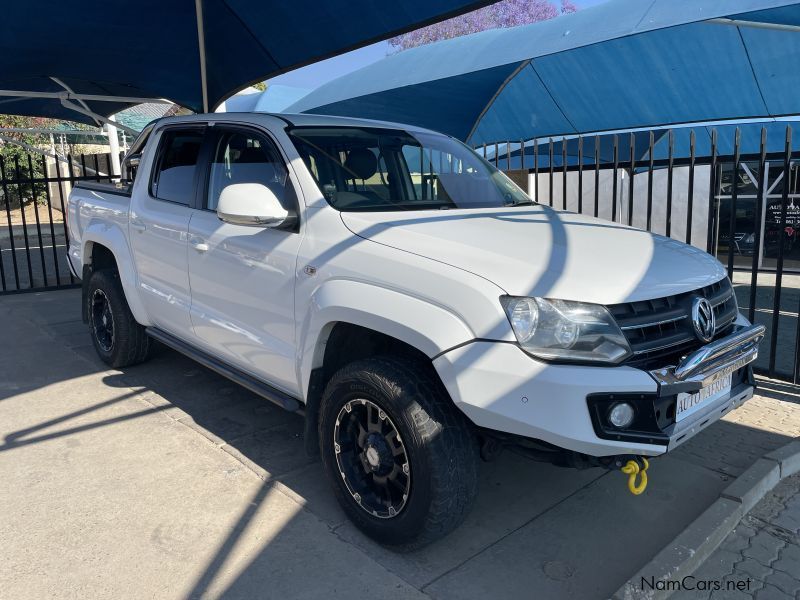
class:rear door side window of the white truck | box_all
[150,129,203,206]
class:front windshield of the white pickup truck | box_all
[289,127,533,211]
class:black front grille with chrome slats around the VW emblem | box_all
[608,277,738,369]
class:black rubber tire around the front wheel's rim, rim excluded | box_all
[319,357,479,551]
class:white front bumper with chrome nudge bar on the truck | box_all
[434,316,763,457]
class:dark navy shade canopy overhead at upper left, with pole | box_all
[0,0,492,123]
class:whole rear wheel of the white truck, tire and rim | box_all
[86,269,151,368]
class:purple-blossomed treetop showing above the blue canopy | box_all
[389,0,577,50]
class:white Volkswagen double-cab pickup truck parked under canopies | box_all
[68,113,764,549]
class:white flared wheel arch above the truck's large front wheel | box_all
[297,279,476,398]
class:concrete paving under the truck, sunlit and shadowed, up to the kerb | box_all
[0,290,800,598]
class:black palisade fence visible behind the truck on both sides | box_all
[0,131,800,383]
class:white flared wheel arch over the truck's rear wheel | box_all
[81,220,150,325]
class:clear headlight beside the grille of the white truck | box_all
[500,296,631,363]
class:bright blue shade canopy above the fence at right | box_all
[287,0,800,146]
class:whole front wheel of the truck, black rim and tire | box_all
[319,357,478,550]
